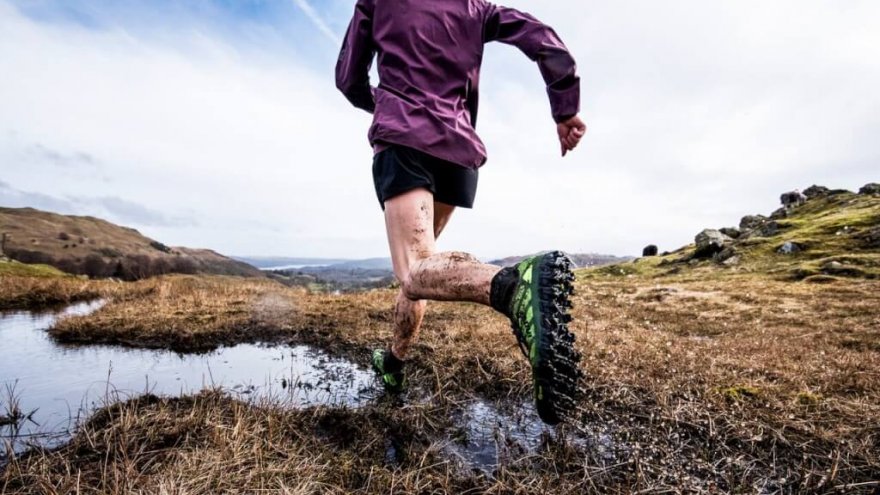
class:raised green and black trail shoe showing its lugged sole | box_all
[509,251,583,425]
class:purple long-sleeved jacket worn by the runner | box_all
[336,0,580,168]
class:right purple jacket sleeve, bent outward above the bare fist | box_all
[483,3,580,122]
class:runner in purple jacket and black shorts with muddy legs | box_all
[336,0,586,424]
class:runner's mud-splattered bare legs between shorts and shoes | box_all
[385,189,500,359]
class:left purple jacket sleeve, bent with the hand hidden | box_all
[336,0,376,113]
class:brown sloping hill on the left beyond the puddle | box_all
[0,207,265,280]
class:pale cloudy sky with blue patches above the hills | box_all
[0,0,880,258]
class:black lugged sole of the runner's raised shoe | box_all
[531,251,584,425]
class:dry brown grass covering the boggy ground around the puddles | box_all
[0,275,880,493]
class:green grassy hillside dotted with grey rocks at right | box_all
[585,184,880,283]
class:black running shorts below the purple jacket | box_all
[373,144,479,210]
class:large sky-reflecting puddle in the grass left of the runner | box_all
[0,301,376,460]
